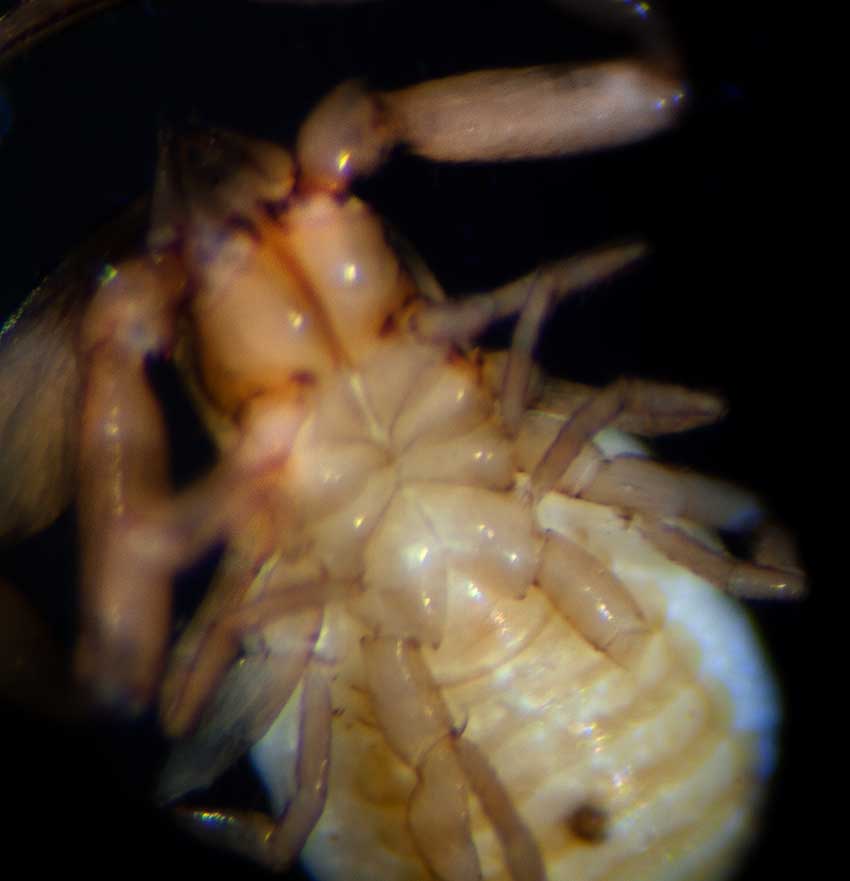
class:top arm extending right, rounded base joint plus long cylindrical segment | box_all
[296,61,683,191]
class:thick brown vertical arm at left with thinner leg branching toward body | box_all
[75,257,292,712]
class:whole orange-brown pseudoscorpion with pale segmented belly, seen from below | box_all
[0,1,802,881]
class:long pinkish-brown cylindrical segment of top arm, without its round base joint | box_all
[382,61,682,162]
